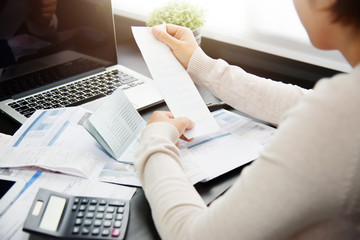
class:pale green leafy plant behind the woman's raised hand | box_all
[146,1,205,31]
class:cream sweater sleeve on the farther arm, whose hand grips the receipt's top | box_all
[187,48,308,125]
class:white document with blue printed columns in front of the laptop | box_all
[0,107,113,178]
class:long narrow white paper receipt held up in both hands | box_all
[132,27,219,138]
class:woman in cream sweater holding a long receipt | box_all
[135,0,360,239]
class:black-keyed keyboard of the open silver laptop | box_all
[8,70,144,118]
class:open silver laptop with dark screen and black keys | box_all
[0,0,163,123]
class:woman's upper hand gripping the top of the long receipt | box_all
[151,24,198,69]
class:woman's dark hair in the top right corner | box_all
[330,0,360,27]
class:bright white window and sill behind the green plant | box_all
[113,0,351,72]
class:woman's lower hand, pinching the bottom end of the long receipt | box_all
[148,111,194,142]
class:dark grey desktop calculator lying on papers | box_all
[23,188,130,240]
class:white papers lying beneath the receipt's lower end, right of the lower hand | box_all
[179,109,276,184]
